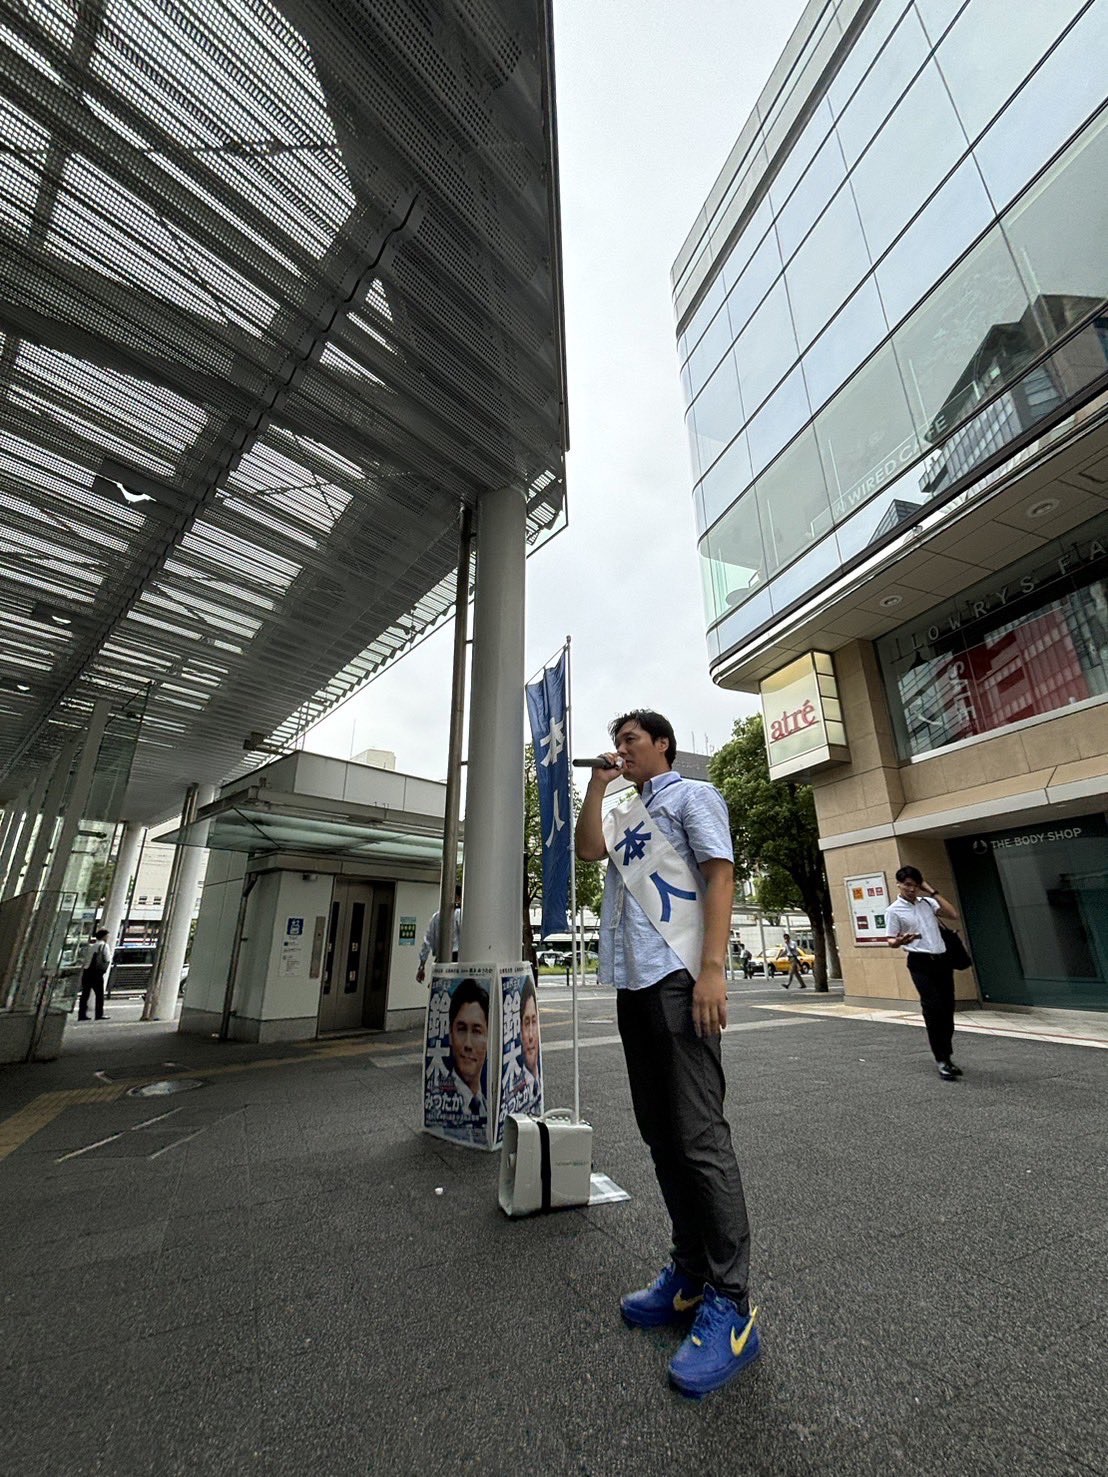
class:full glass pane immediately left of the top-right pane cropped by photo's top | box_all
[851,62,968,260]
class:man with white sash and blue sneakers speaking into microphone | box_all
[576,709,761,1396]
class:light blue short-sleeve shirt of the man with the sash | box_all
[598,770,734,990]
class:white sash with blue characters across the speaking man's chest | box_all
[604,795,705,979]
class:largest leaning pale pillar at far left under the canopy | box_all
[15,697,111,1009]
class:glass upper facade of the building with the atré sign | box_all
[674,0,1108,676]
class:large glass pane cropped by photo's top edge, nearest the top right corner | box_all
[937,0,1084,143]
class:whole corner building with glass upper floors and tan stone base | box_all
[674,0,1108,1010]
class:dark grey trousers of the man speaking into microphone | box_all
[616,969,750,1313]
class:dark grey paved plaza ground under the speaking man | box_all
[0,981,1108,1477]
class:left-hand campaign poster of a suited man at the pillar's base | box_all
[423,963,499,1149]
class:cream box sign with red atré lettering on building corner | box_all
[761,651,849,780]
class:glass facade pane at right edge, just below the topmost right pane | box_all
[974,3,1108,212]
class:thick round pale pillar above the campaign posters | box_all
[459,487,526,963]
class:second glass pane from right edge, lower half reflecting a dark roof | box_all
[892,226,1043,445]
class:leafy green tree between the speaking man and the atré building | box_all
[709,715,839,990]
